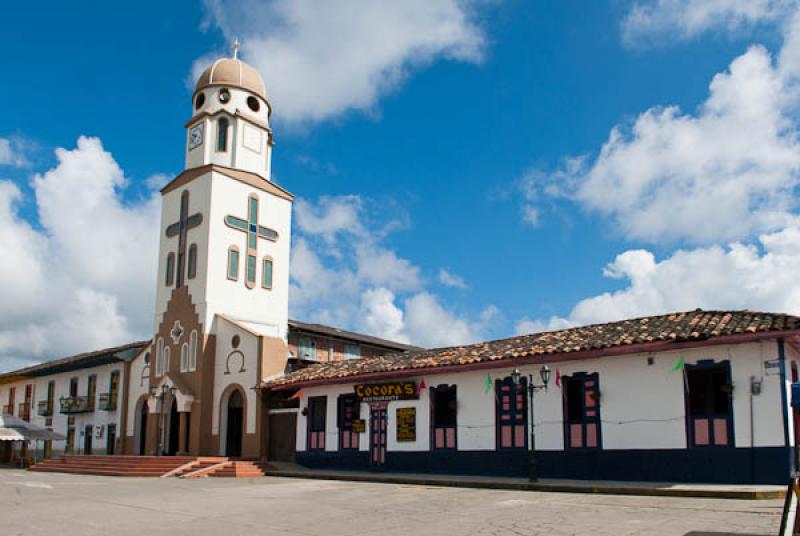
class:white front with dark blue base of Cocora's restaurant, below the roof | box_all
[287,328,800,483]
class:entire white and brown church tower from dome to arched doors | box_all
[139,44,293,457]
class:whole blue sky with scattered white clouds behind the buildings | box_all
[0,0,800,369]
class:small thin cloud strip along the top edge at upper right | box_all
[622,0,798,44]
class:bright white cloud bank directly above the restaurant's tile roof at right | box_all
[517,226,800,331]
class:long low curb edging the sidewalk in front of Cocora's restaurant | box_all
[264,471,786,500]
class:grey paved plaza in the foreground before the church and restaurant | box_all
[0,469,782,536]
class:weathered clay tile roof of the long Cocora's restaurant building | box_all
[264,309,800,388]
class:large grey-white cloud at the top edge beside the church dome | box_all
[200,0,486,122]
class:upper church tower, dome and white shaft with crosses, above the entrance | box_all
[149,44,293,386]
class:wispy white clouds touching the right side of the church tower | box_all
[291,196,498,346]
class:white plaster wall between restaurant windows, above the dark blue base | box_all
[297,341,798,452]
